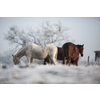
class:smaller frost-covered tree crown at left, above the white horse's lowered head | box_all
[4,25,30,48]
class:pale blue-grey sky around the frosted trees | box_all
[0,17,100,60]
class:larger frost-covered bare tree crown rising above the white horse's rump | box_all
[28,21,69,45]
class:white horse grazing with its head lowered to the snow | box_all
[12,44,58,65]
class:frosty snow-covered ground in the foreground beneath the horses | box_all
[0,64,100,84]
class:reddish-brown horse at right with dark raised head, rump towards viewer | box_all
[63,42,84,66]
